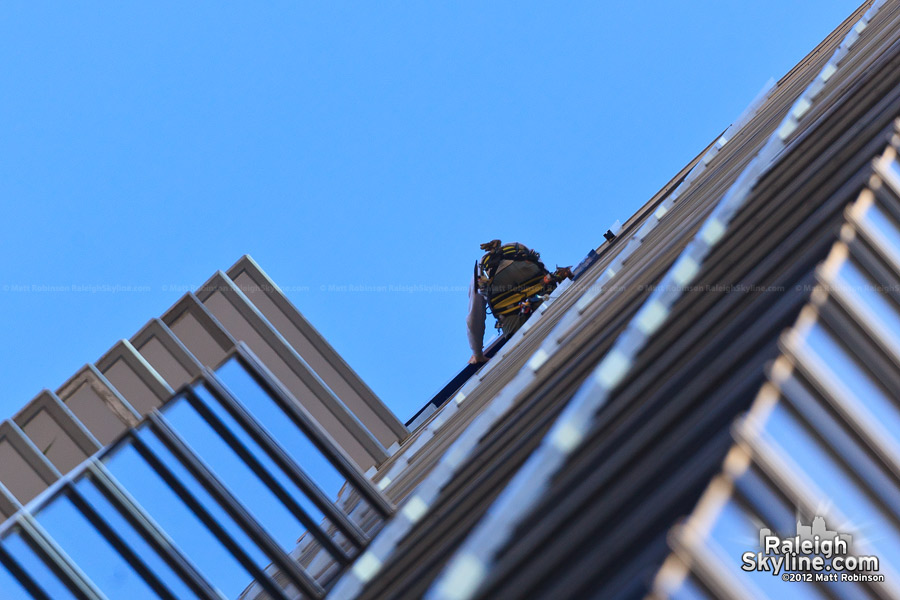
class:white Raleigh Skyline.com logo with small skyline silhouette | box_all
[741,517,884,581]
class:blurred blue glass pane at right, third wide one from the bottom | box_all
[806,323,900,450]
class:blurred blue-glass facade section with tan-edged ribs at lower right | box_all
[653,141,900,598]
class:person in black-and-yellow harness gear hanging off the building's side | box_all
[466,240,572,365]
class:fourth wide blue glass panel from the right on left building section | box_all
[36,495,158,600]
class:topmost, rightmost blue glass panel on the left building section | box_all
[216,358,344,500]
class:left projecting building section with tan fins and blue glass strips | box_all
[0,257,408,599]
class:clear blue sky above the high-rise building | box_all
[0,0,858,420]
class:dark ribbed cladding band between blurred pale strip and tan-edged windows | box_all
[481,5,900,598]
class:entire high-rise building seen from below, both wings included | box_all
[0,0,900,600]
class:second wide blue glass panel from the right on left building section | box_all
[164,398,324,551]
